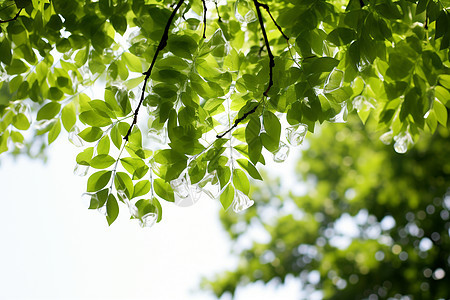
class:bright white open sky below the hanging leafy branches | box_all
[0,137,301,300]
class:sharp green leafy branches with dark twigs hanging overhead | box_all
[0,0,450,226]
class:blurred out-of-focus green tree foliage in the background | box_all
[204,114,450,299]
